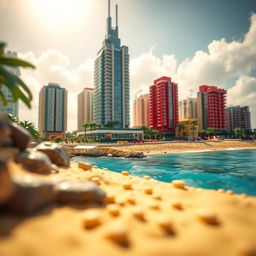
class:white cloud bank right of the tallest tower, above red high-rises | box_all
[131,14,256,127]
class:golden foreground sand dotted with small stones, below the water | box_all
[0,160,256,256]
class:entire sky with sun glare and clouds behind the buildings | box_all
[0,0,256,128]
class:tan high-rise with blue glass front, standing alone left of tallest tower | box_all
[38,83,67,138]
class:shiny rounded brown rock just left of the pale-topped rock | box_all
[15,149,56,174]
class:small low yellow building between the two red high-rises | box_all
[175,119,198,140]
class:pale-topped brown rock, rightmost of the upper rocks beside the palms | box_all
[36,142,70,167]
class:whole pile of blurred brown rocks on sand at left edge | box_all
[0,116,105,214]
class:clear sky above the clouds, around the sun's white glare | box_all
[0,0,256,65]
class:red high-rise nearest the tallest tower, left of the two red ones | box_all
[150,76,179,132]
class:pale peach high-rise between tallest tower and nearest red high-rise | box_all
[133,94,149,128]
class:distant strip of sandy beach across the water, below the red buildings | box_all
[111,140,256,154]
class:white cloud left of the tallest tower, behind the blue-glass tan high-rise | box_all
[19,50,93,130]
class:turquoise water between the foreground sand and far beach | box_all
[72,150,256,196]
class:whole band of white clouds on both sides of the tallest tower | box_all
[20,14,256,130]
